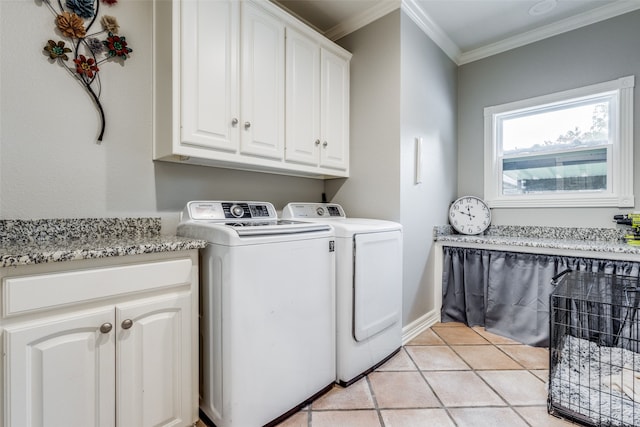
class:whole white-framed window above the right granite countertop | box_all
[484,76,635,211]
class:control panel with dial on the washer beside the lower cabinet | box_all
[182,201,278,221]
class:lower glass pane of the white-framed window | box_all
[502,147,608,195]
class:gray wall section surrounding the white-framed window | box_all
[457,12,640,227]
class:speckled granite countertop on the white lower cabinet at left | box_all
[0,218,206,267]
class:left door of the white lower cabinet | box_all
[4,307,115,427]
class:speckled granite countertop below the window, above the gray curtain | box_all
[433,225,640,255]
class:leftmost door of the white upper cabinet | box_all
[181,0,239,152]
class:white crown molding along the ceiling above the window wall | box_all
[456,0,640,65]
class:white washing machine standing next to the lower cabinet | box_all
[177,201,336,427]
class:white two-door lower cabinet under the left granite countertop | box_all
[0,255,198,427]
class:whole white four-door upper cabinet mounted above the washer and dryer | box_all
[153,0,351,178]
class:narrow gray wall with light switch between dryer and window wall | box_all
[400,13,457,324]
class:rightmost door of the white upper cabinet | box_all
[320,49,349,170]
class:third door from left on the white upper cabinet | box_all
[285,28,320,166]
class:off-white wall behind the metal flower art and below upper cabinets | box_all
[0,0,324,232]
